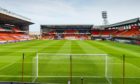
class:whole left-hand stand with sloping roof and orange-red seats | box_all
[0,8,33,44]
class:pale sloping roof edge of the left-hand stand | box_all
[0,7,34,24]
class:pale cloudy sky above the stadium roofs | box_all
[0,0,140,31]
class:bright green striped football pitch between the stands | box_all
[0,40,140,84]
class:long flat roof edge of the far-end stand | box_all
[41,24,93,28]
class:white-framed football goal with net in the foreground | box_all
[32,53,112,84]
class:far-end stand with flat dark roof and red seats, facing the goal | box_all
[41,25,92,40]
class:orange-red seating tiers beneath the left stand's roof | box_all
[0,25,30,42]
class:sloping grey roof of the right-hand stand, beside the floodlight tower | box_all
[105,18,140,28]
